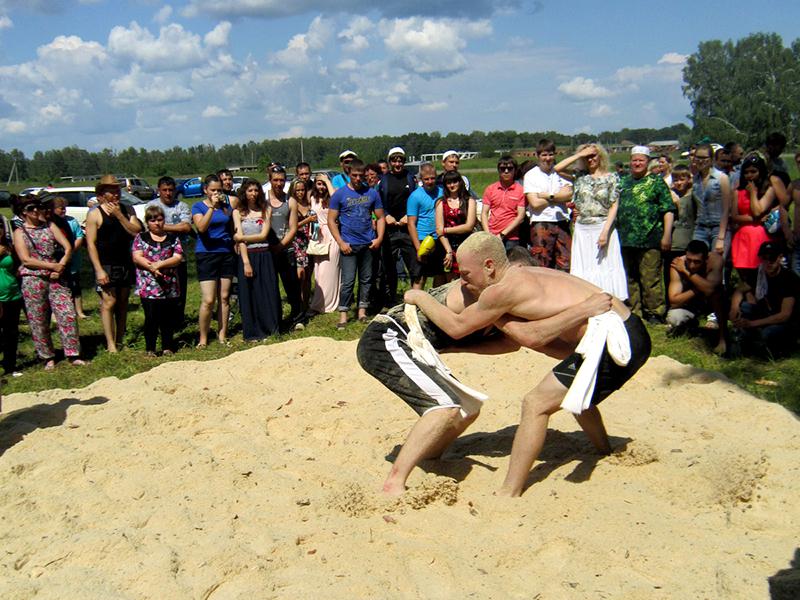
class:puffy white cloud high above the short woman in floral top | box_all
[108,21,207,72]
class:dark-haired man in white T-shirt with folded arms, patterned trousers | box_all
[523,138,572,271]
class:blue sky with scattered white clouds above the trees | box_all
[0,0,800,156]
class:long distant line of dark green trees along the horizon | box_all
[0,123,690,182]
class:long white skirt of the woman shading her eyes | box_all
[569,223,628,300]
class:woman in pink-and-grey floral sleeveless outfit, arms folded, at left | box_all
[14,199,85,371]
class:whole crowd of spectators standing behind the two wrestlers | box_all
[0,134,800,373]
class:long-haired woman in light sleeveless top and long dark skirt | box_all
[233,179,282,342]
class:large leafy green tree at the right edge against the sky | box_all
[683,33,800,147]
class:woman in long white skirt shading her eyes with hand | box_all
[555,143,628,300]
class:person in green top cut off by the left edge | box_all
[0,218,22,377]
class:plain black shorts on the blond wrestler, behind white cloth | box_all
[553,313,650,406]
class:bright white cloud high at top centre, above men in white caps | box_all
[380,17,492,77]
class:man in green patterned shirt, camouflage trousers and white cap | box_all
[617,146,676,323]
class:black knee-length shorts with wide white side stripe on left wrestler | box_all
[356,315,461,416]
